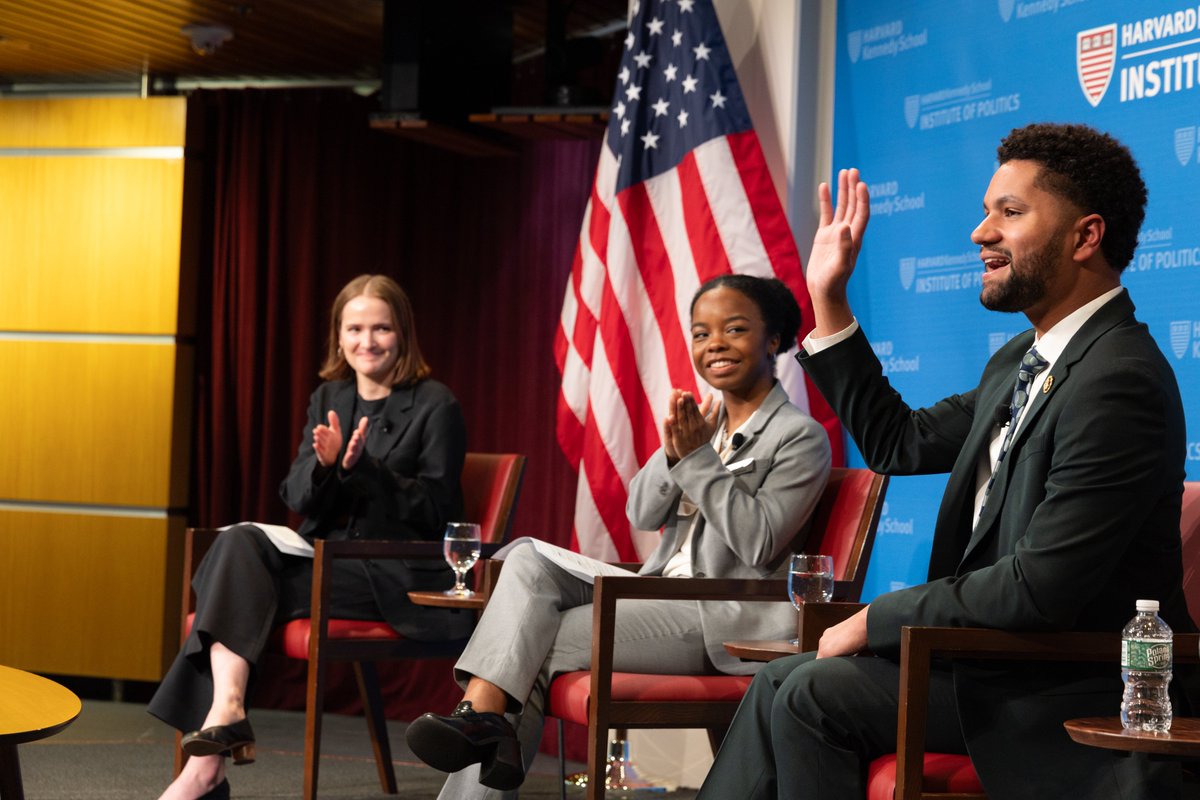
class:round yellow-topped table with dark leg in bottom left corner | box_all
[0,667,83,800]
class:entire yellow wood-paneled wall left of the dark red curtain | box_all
[0,97,193,680]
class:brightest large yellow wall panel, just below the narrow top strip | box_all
[0,155,184,333]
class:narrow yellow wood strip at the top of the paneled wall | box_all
[0,97,187,148]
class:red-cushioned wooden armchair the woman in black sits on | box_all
[175,453,526,800]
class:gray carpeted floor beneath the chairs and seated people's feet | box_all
[18,700,696,800]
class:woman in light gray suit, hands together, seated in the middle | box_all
[407,275,830,800]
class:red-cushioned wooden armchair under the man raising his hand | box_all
[799,482,1200,800]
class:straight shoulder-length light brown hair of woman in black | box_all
[319,275,431,386]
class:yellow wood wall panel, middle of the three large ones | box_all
[0,339,177,507]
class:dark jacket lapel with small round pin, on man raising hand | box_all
[961,291,1134,561]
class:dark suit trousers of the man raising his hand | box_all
[696,652,966,800]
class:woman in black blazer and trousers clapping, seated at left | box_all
[149,275,469,800]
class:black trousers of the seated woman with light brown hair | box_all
[146,525,382,730]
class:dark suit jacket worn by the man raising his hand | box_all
[805,295,1190,656]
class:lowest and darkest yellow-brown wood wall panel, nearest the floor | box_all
[0,509,184,680]
